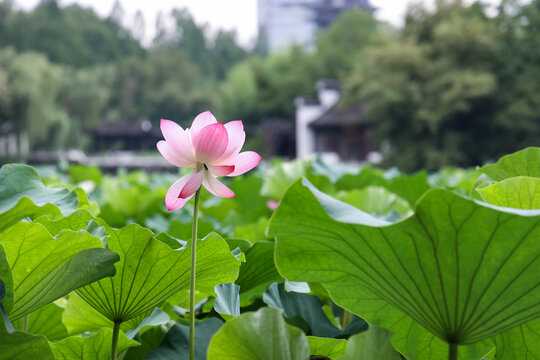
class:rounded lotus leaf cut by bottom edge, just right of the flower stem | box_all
[208,308,309,360]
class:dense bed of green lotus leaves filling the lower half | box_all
[0,148,540,360]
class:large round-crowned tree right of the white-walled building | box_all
[346,1,510,170]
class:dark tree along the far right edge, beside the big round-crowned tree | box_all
[489,0,540,157]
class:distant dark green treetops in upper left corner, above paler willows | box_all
[0,0,144,66]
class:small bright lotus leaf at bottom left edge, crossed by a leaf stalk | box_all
[50,328,139,360]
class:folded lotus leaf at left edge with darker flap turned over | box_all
[0,222,118,320]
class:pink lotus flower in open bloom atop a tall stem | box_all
[157,111,261,211]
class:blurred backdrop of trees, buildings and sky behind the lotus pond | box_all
[0,0,540,171]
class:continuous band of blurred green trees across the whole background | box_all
[0,0,540,170]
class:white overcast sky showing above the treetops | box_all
[15,0,499,45]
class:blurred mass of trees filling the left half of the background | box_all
[0,0,247,155]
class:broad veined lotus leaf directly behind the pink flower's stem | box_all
[40,211,240,322]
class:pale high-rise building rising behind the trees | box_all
[258,0,374,52]
